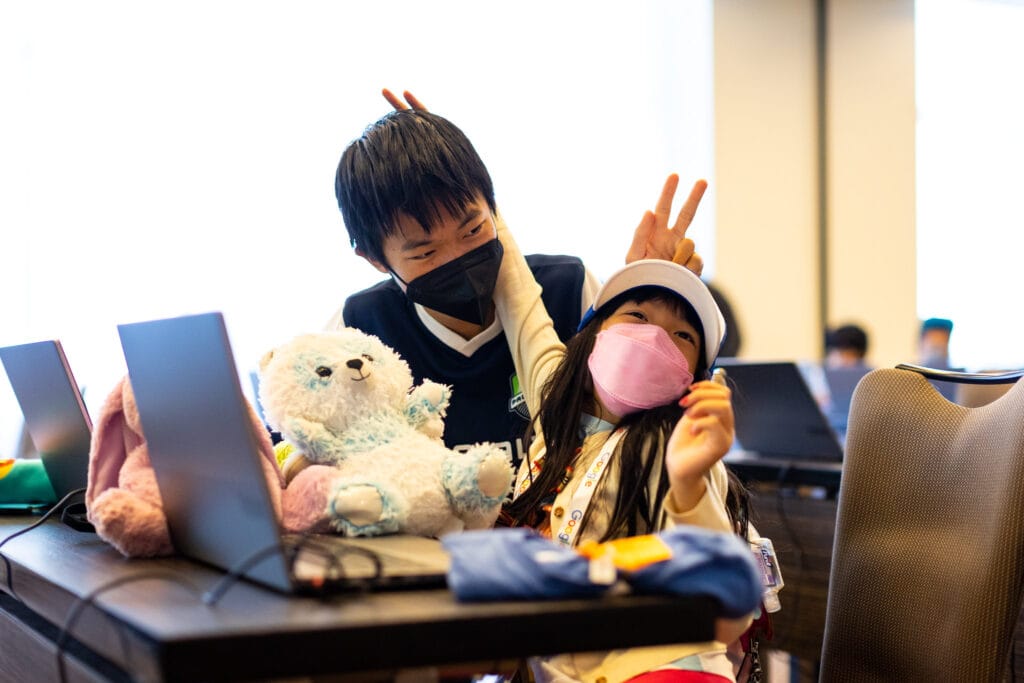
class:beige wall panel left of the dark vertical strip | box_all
[715,0,821,358]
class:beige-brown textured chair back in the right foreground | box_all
[820,366,1024,683]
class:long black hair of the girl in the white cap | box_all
[505,287,748,542]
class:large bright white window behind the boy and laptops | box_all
[0,0,714,458]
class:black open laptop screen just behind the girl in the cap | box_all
[716,358,843,462]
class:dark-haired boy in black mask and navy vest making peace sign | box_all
[328,96,699,463]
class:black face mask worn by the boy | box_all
[391,238,505,325]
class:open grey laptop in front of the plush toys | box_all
[118,312,449,593]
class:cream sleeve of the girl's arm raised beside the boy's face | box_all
[495,216,565,415]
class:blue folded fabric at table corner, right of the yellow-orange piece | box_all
[624,526,764,617]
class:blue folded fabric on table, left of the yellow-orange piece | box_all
[441,527,609,601]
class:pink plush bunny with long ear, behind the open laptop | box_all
[85,377,336,557]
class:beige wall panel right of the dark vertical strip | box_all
[825,0,916,366]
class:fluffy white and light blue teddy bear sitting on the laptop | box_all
[259,328,512,537]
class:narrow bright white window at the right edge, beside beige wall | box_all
[915,0,1024,370]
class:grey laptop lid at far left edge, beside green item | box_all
[0,339,92,501]
